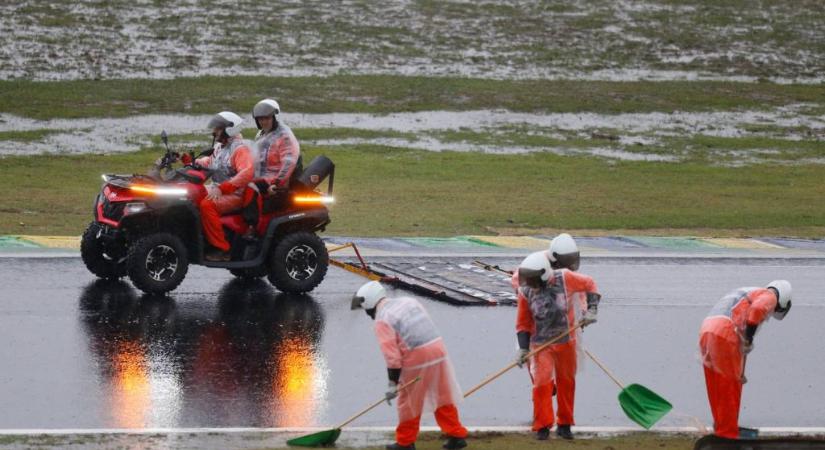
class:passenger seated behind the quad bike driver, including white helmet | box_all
[252,98,303,189]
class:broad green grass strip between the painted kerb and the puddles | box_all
[0,144,825,237]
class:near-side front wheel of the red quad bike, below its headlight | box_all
[126,233,189,294]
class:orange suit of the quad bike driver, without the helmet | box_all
[198,134,255,252]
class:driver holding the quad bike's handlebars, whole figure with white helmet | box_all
[196,111,255,261]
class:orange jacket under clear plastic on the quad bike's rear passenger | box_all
[255,122,301,187]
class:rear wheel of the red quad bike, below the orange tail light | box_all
[269,231,329,294]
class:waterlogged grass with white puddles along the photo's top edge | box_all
[0,0,825,82]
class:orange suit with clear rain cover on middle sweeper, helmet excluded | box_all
[513,269,598,431]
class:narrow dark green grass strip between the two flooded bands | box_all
[0,75,825,120]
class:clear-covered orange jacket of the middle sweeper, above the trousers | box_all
[516,269,598,344]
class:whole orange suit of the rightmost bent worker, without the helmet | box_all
[699,288,776,439]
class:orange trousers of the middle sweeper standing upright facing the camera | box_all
[530,341,577,431]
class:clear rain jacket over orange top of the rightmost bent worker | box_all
[699,287,776,377]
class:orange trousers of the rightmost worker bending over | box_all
[699,333,743,439]
